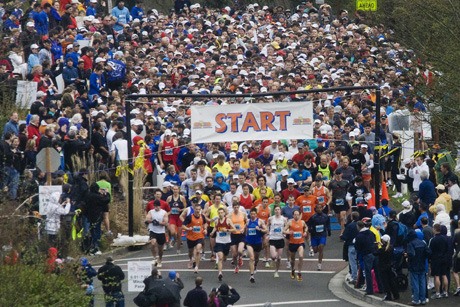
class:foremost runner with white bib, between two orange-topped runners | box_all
[210,208,236,281]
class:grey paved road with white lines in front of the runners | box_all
[94,235,353,307]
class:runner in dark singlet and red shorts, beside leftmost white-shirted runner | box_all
[166,185,187,253]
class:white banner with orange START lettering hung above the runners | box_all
[191,101,313,143]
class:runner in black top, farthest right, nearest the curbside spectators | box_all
[329,170,350,235]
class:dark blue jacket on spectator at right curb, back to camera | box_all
[406,229,431,273]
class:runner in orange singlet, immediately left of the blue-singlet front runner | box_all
[229,199,248,273]
